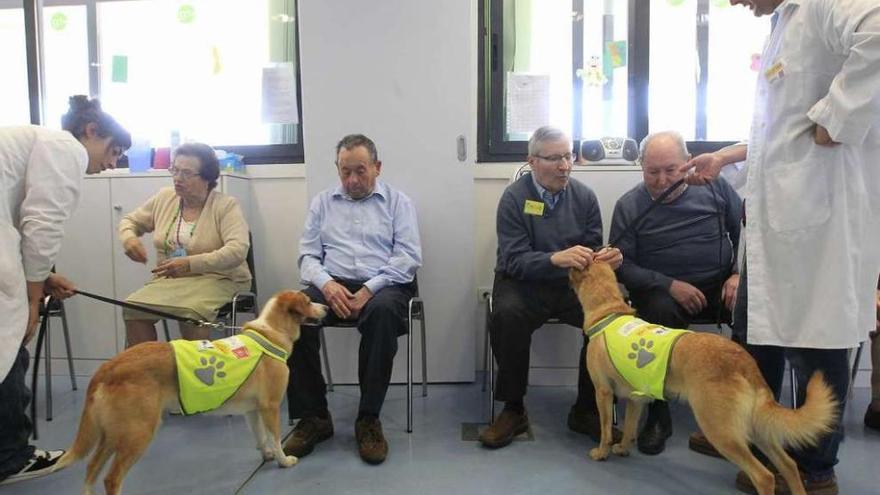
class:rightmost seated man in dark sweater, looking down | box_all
[610,132,742,455]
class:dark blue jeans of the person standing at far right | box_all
[733,260,849,479]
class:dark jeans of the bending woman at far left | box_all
[0,347,34,481]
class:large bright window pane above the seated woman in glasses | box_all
[98,0,298,146]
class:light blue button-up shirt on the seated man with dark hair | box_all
[299,180,422,294]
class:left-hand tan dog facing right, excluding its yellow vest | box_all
[49,291,327,495]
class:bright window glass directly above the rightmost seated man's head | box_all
[648,0,770,141]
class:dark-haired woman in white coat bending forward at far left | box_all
[0,96,131,484]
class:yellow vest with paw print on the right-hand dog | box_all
[587,314,690,400]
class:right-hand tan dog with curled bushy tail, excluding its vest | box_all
[569,262,837,495]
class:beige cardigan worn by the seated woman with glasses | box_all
[119,187,251,282]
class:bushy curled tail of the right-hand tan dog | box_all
[754,371,838,454]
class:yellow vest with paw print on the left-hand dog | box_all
[171,330,287,415]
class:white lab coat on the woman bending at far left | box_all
[0,126,88,380]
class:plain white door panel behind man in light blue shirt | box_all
[299,0,477,382]
